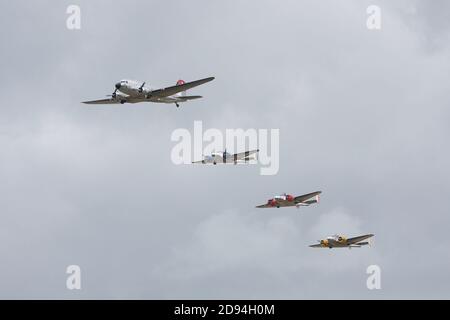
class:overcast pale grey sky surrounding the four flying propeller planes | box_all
[0,0,450,299]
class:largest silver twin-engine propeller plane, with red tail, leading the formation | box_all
[83,77,215,108]
